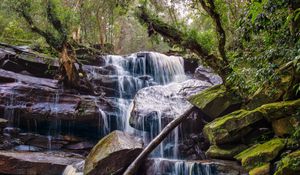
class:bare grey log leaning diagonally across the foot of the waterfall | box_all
[123,106,195,175]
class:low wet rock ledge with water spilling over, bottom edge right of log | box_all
[138,158,247,175]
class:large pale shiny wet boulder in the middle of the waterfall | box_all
[130,80,211,131]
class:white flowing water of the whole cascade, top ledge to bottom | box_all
[64,52,218,175]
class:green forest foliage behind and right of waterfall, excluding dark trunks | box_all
[0,0,300,99]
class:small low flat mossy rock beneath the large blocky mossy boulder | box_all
[206,145,247,159]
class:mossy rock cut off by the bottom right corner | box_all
[274,150,300,175]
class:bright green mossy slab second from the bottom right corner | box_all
[235,138,286,170]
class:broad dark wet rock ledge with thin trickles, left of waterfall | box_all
[0,69,114,138]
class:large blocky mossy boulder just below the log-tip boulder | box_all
[203,110,263,145]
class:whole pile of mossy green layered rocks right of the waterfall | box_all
[190,86,300,175]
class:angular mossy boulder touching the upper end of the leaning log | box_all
[189,85,241,119]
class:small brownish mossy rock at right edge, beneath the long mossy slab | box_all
[272,117,300,136]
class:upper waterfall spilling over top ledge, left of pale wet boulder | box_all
[96,52,186,137]
